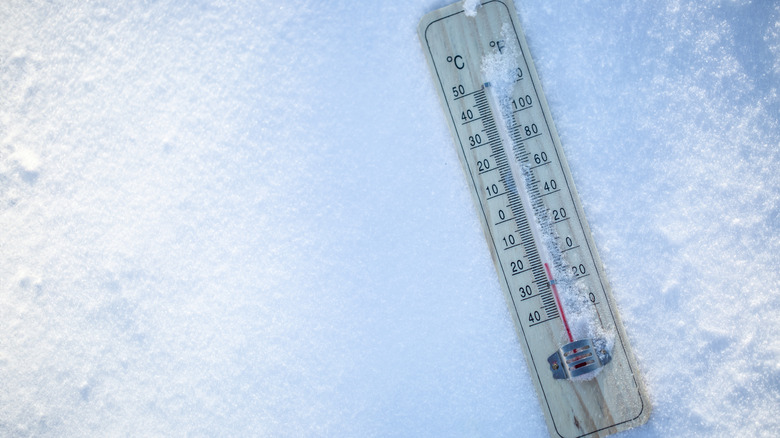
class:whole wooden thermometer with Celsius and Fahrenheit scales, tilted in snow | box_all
[419,0,651,437]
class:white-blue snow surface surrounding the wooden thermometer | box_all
[0,0,780,437]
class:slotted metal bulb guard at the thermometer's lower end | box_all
[547,339,612,379]
